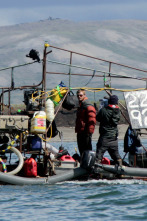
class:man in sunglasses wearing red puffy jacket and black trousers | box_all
[75,89,96,155]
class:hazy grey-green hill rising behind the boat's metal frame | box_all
[0,19,147,103]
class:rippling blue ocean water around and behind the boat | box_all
[0,140,147,221]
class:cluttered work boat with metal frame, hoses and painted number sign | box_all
[0,43,147,185]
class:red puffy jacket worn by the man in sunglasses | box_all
[75,99,96,134]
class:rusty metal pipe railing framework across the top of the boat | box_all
[0,45,147,113]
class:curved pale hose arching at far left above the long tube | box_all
[7,147,24,175]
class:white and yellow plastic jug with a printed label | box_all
[31,111,46,134]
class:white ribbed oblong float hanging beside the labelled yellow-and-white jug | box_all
[45,99,55,122]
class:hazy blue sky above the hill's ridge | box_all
[0,0,147,26]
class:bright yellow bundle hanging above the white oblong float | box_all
[50,85,67,106]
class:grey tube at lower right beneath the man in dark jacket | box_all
[97,164,147,177]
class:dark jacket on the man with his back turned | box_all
[96,105,120,138]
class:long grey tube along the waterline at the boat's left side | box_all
[0,167,87,185]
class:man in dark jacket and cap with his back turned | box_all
[96,95,122,165]
